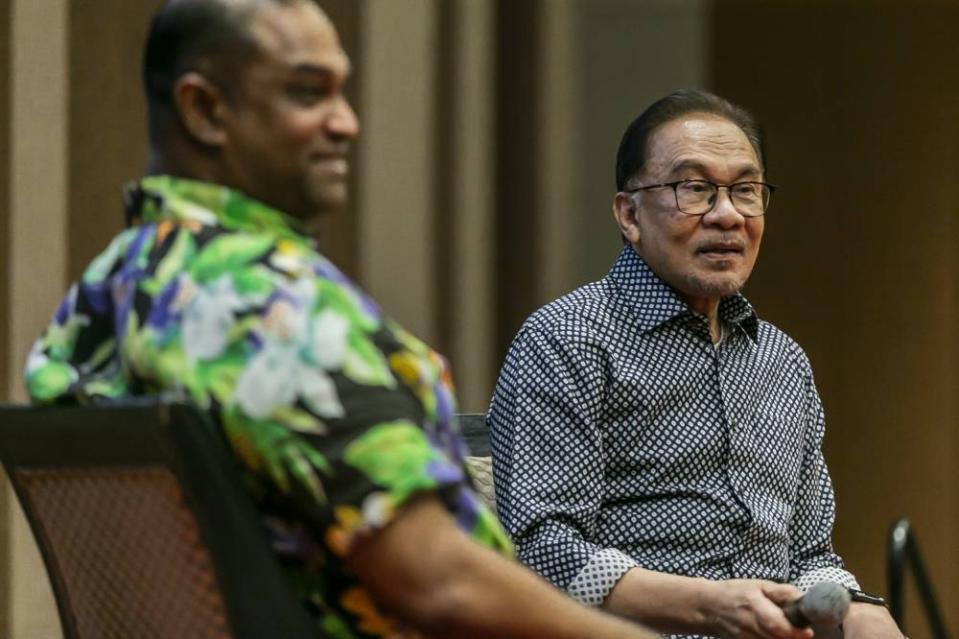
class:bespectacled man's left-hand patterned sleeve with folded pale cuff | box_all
[488,326,636,605]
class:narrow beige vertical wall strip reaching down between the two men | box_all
[433,0,498,412]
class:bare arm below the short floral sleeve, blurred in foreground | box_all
[345,495,655,639]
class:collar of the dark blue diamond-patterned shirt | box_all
[607,246,759,342]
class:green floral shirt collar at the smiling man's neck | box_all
[123,175,309,241]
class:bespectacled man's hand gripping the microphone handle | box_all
[705,579,813,639]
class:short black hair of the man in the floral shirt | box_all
[143,0,257,112]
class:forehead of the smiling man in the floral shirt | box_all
[249,2,350,76]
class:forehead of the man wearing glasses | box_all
[646,113,761,174]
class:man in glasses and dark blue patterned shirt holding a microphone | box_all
[488,91,900,639]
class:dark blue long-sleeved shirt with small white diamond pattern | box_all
[488,247,855,639]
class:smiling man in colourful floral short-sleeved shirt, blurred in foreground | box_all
[26,0,651,639]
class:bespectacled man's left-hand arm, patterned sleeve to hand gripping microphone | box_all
[489,326,811,639]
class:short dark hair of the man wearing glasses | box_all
[616,89,766,191]
